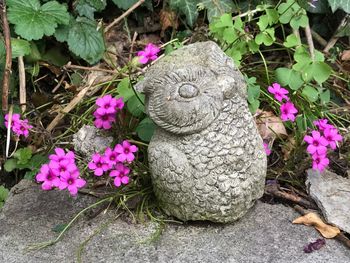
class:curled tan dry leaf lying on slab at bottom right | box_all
[292,213,340,238]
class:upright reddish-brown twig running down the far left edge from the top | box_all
[0,0,12,113]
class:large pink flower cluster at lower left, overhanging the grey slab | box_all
[36,148,86,196]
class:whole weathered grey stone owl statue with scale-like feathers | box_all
[136,41,267,223]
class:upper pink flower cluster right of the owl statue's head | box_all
[268,83,298,121]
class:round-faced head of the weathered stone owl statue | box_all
[136,41,247,134]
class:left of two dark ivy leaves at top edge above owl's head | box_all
[170,0,198,27]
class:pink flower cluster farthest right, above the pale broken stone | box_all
[304,119,343,172]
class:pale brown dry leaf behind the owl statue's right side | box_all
[255,110,288,141]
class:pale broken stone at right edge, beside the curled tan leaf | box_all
[306,169,350,233]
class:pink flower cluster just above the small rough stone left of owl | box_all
[93,95,124,130]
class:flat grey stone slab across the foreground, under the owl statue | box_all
[0,181,350,263]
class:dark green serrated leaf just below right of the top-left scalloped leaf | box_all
[55,17,105,64]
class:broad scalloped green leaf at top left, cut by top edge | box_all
[7,0,69,40]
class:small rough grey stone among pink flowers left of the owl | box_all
[73,125,113,158]
